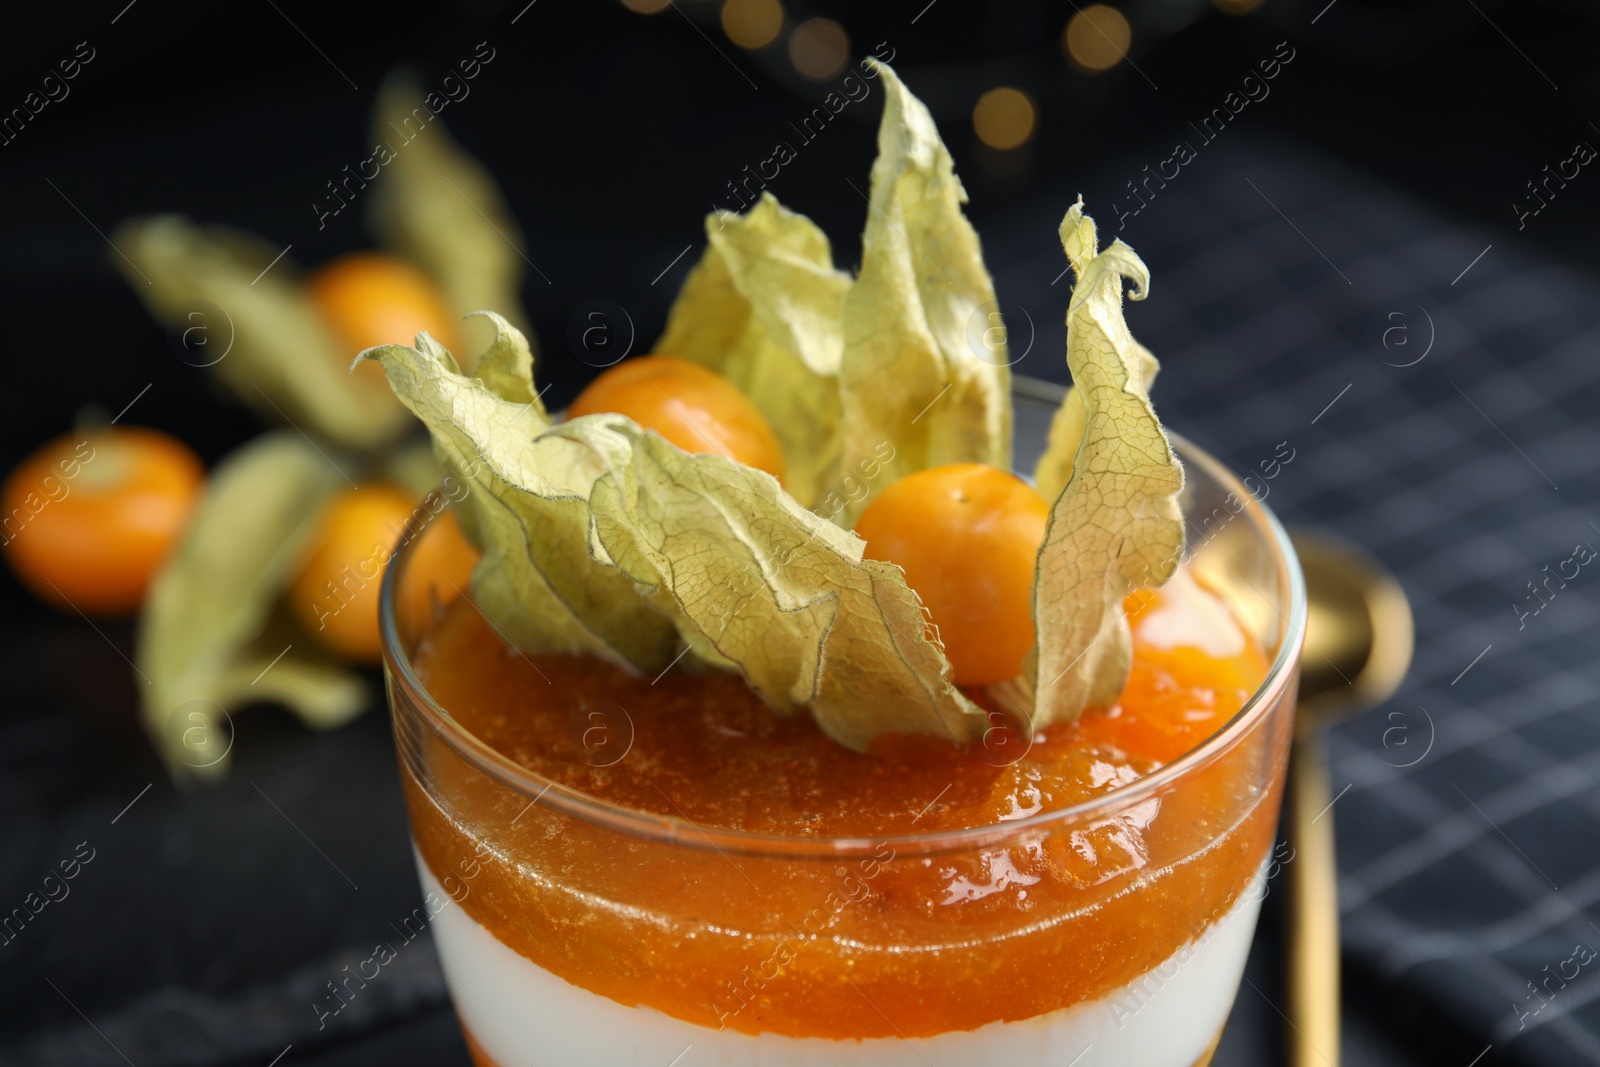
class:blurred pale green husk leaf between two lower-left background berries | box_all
[136,430,368,777]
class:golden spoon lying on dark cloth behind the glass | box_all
[1288,530,1413,1067]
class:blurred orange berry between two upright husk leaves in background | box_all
[307,251,461,377]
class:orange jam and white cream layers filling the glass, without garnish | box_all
[408,574,1275,1067]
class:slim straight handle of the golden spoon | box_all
[1288,736,1339,1067]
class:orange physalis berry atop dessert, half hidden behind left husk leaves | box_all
[566,355,784,480]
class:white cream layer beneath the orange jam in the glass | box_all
[416,854,1262,1067]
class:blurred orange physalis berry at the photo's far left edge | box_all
[0,426,205,616]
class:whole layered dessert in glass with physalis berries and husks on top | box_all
[363,66,1302,1067]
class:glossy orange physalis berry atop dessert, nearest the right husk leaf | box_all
[856,464,1050,686]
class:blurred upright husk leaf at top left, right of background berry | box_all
[368,75,528,358]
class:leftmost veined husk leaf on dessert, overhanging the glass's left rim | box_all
[358,314,677,670]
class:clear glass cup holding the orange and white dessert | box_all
[381,379,1306,1067]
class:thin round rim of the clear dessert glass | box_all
[378,376,1306,859]
